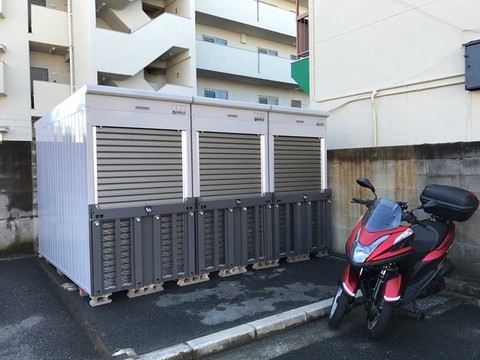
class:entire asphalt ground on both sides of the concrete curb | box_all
[0,257,480,360]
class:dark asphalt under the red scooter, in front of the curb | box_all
[206,292,480,360]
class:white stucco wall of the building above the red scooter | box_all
[310,0,480,148]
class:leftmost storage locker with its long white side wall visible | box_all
[35,86,195,305]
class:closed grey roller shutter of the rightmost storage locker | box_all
[273,136,321,193]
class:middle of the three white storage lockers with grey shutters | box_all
[192,98,273,276]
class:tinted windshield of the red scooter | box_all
[365,199,402,232]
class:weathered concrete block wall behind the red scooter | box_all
[328,142,480,281]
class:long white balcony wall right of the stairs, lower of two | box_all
[197,41,295,85]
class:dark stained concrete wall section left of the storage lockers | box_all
[0,141,37,257]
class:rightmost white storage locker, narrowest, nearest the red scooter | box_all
[269,107,331,261]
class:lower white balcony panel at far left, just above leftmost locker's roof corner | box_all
[32,80,70,116]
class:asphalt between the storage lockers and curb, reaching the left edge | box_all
[0,257,344,359]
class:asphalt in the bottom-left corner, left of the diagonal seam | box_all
[0,258,104,360]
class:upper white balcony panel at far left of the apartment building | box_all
[29,5,68,46]
